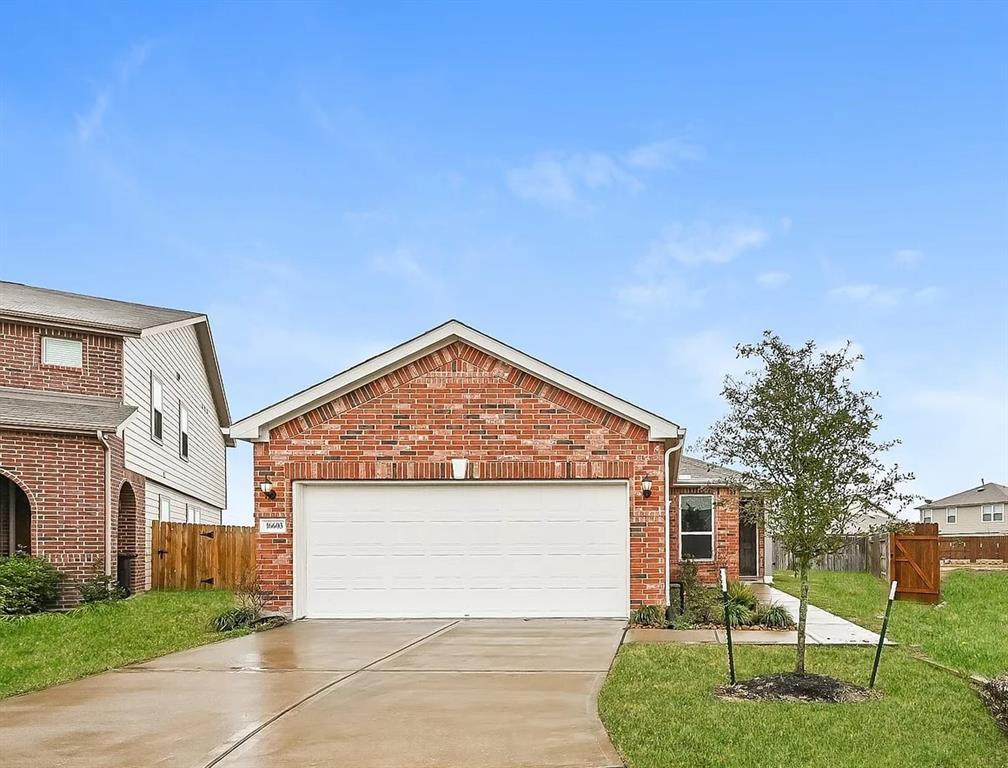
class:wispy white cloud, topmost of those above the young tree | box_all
[506,139,704,210]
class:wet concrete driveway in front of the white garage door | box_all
[0,619,624,768]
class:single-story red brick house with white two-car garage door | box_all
[229,321,763,618]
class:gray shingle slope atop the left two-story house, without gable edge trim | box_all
[0,281,203,334]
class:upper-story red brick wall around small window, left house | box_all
[0,323,123,397]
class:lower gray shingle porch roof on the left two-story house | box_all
[0,387,136,432]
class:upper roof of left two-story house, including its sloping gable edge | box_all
[0,280,231,427]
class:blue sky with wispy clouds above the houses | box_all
[0,3,1008,522]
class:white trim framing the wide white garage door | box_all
[288,480,633,620]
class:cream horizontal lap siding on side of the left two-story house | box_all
[123,326,227,507]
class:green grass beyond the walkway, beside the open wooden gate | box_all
[773,570,1008,677]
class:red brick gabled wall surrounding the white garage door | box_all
[254,343,673,613]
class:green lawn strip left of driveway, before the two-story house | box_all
[0,590,245,697]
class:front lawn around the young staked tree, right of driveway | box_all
[599,644,1008,768]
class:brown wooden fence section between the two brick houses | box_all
[150,520,256,590]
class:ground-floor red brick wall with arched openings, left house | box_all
[0,430,144,606]
